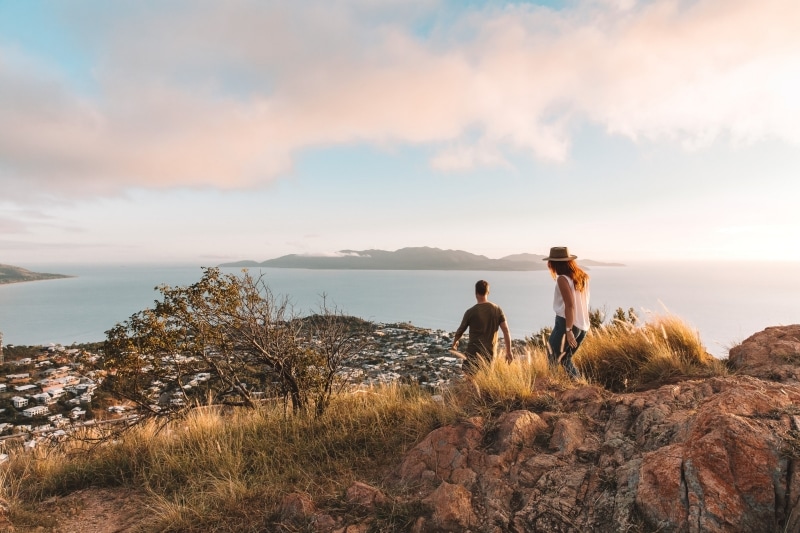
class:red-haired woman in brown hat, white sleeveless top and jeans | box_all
[543,246,590,379]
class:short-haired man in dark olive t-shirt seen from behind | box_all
[453,280,512,374]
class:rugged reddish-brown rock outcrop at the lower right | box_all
[284,325,800,533]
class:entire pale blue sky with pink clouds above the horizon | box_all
[0,0,800,266]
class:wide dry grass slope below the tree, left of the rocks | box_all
[0,386,460,531]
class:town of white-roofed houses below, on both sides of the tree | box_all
[0,323,482,456]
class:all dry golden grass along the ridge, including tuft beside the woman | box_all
[0,317,725,531]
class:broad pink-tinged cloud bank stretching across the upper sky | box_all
[0,0,800,198]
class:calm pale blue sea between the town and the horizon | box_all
[0,263,800,357]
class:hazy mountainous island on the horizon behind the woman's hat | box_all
[220,247,624,271]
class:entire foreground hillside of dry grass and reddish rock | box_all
[6,325,800,533]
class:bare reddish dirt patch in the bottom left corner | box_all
[14,488,152,533]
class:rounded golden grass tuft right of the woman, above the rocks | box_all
[574,315,726,392]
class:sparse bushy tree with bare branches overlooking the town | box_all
[104,268,370,416]
